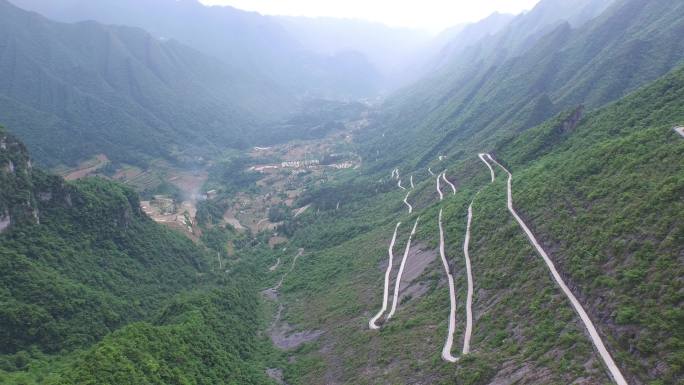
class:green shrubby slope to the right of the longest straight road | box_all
[498,69,684,383]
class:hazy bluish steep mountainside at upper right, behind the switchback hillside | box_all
[364,0,684,172]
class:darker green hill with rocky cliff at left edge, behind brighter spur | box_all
[0,126,206,354]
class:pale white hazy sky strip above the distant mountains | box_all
[200,0,539,32]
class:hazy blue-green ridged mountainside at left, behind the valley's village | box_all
[0,0,293,165]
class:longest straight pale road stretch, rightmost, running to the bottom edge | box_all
[486,154,627,385]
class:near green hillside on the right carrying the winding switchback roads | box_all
[274,64,684,384]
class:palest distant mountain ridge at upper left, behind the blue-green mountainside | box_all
[9,0,380,98]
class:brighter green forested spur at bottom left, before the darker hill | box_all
[47,282,269,385]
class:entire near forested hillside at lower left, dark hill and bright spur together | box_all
[0,128,266,384]
